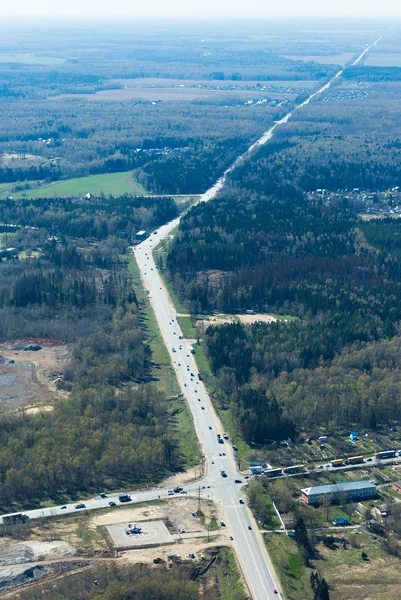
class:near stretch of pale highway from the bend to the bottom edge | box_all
[135,237,279,600]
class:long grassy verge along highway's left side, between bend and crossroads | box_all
[129,257,201,467]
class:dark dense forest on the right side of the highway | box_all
[166,75,401,445]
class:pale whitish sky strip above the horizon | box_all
[0,0,401,20]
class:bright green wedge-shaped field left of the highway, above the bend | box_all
[0,171,147,200]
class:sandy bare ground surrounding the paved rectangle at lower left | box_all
[0,498,232,598]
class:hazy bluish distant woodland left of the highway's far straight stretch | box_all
[0,22,382,194]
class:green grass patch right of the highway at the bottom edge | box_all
[265,533,313,600]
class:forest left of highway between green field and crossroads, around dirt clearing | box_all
[0,191,187,511]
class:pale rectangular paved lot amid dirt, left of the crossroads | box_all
[107,521,175,548]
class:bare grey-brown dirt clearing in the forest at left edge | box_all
[0,338,71,412]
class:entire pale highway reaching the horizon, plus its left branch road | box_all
[0,38,380,600]
